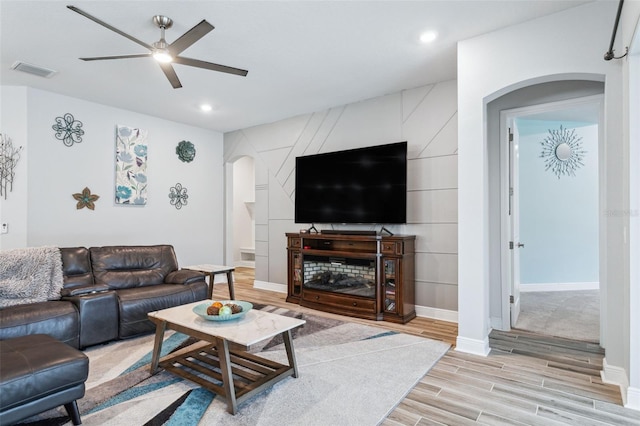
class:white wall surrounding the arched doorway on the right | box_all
[457,2,627,382]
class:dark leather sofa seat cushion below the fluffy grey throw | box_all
[0,301,80,348]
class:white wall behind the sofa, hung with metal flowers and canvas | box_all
[0,87,223,265]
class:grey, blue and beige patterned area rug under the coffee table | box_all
[20,306,449,426]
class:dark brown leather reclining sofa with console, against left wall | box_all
[0,245,207,348]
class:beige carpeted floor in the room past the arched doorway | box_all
[515,290,600,343]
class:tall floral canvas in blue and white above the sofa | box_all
[116,126,147,205]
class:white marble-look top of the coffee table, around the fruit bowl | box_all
[149,300,306,347]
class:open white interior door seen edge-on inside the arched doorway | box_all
[509,124,524,327]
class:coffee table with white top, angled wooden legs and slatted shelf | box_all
[149,301,306,414]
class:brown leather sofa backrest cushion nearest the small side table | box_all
[90,245,178,290]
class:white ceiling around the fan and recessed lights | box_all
[0,0,588,132]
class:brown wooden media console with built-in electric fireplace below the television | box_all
[286,232,416,323]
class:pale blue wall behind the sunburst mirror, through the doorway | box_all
[516,118,600,291]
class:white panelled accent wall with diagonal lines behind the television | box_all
[224,80,458,311]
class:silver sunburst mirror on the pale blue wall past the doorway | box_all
[540,126,587,179]
